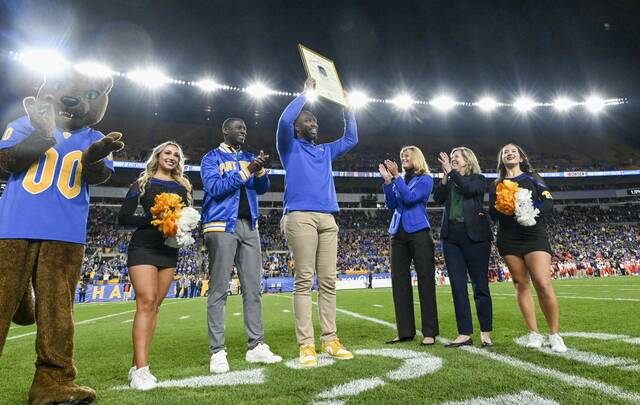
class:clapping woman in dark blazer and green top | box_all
[433,147,493,347]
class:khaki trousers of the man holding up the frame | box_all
[281,211,338,345]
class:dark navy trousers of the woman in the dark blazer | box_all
[442,223,493,335]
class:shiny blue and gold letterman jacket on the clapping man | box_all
[200,143,270,233]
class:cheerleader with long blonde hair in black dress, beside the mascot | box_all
[118,142,192,390]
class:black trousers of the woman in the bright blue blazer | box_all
[391,227,440,338]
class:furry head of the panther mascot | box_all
[36,68,113,131]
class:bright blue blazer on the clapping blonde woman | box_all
[382,175,433,235]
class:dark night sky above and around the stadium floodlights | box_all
[0,0,640,144]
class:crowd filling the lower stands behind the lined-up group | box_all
[82,204,640,284]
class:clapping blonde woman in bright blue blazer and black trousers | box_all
[378,146,439,346]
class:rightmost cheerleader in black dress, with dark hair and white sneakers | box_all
[489,144,567,352]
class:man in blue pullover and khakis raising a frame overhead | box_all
[276,78,358,367]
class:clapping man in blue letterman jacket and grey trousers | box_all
[200,118,282,373]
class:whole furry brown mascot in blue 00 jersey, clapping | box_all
[0,64,124,404]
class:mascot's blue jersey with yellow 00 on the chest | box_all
[0,116,114,244]
